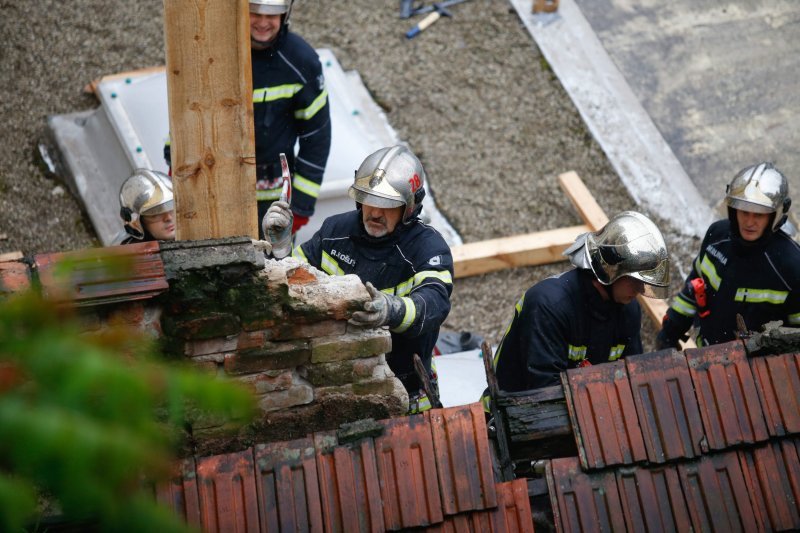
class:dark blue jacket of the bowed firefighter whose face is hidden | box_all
[494,269,642,391]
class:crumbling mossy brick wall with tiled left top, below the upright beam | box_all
[0,238,408,454]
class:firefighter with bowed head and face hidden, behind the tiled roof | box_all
[483,211,669,392]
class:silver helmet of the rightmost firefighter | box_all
[725,163,792,231]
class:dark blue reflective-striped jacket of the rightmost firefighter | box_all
[659,220,800,346]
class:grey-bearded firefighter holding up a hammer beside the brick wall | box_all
[263,145,453,413]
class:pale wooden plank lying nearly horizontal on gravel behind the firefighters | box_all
[451,225,592,278]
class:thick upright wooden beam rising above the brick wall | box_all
[164,0,258,240]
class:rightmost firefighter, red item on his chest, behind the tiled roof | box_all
[656,163,800,349]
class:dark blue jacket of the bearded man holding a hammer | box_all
[292,209,453,394]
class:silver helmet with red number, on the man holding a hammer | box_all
[348,145,425,222]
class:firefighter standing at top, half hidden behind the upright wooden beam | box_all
[164,0,331,239]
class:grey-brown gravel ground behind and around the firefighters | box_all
[0,0,698,344]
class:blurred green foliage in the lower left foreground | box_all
[0,291,254,531]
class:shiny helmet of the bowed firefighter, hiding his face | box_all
[564,211,670,299]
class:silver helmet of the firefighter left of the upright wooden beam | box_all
[119,168,175,240]
